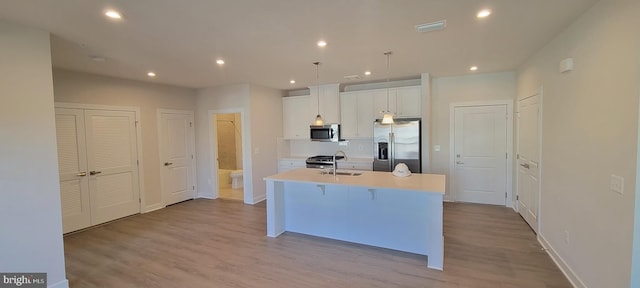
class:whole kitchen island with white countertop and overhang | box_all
[264,168,445,270]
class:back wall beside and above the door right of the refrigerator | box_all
[423,72,516,200]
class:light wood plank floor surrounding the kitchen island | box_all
[64,199,571,288]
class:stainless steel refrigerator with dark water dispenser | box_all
[373,118,422,173]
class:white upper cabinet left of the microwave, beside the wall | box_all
[282,95,315,139]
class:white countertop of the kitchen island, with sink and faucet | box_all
[264,168,446,194]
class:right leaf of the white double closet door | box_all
[85,110,140,225]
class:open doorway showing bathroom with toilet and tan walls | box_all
[213,113,244,201]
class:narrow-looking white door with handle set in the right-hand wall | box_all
[517,95,540,232]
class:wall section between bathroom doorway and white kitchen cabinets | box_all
[244,85,284,203]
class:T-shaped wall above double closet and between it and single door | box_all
[53,69,197,212]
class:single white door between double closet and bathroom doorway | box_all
[160,113,195,205]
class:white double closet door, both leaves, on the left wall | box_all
[56,108,140,233]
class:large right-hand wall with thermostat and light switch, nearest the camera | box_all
[518,0,640,287]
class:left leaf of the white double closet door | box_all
[56,108,91,233]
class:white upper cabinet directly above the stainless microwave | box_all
[307,84,340,124]
